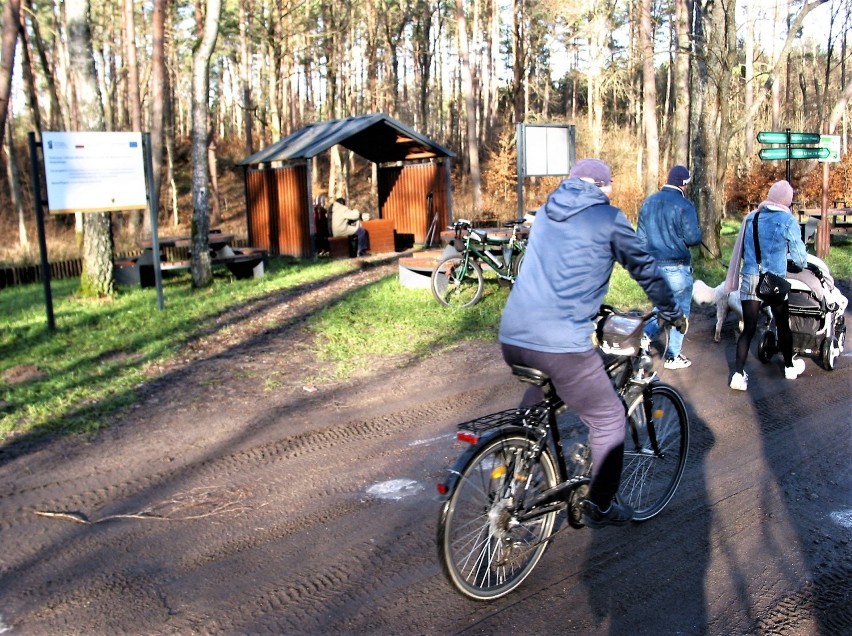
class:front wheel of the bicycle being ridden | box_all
[618,384,689,521]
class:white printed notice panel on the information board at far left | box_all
[42,132,148,214]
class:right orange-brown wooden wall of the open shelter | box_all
[378,163,449,243]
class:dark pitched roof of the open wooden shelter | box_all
[238,113,456,166]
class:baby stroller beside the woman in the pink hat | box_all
[757,254,848,371]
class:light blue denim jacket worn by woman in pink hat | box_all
[742,205,807,276]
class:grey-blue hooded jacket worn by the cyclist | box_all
[499,178,682,353]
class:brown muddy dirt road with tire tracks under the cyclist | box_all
[0,266,852,635]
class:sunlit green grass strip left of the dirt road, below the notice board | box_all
[0,258,357,440]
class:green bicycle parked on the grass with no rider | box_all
[431,219,526,307]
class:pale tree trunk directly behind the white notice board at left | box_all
[65,0,115,296]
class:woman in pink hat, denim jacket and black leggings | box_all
[730,180,807,391]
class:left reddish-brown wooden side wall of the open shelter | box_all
[246,165,313,258]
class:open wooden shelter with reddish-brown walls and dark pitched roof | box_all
[238,113,456,258]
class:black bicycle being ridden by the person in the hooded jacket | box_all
[437,306,689,600]
